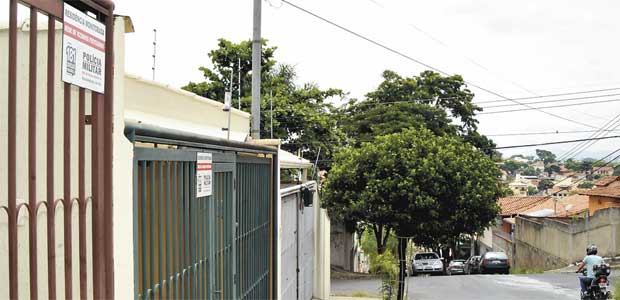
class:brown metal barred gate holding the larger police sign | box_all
[0,0,114,299]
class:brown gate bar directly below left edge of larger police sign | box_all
[63,83,73,299]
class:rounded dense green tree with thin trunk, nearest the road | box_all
[322,128,503,295]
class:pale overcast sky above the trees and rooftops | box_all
[116,0,620,157]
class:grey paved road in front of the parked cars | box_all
[332,274,615,300]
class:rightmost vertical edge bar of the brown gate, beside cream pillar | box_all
[103,1,114,299]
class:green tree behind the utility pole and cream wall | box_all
[182,39,345,169]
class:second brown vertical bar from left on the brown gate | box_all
[28,7,38,299]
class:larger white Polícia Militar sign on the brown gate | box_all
[62,3,105,93]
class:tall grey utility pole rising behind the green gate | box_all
[250,0,263,140]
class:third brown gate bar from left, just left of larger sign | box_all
[46,12,56,299]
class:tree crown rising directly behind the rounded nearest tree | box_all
[341,70,498,152]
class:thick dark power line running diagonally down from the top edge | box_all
[282,0,599,129]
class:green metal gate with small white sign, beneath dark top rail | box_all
[128,126,277,299]
